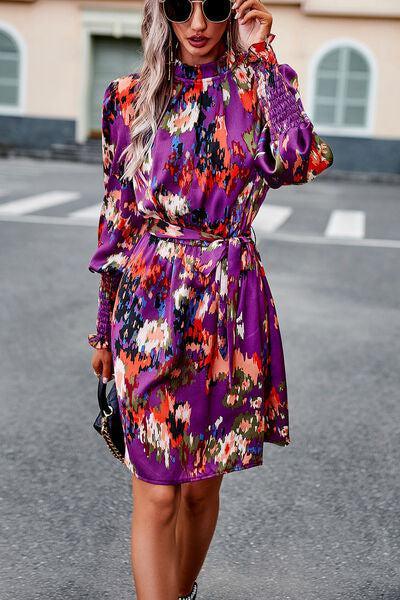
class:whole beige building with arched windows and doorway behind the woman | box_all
[0,0,400,173]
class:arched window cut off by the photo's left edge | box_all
[0,29,21,107]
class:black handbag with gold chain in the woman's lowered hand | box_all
[93,377,125,463]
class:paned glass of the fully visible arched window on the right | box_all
[313,45,371,130]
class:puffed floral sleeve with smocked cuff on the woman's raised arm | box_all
[247,36,333,188]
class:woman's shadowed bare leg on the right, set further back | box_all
[176,474,223,596]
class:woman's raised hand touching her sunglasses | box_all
[232,0,272,49]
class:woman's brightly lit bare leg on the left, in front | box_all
[131,475,181,600]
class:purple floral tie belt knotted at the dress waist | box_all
[148,220,261,386]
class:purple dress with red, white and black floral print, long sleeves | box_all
[88,41,333,484]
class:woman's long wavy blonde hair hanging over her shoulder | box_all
[121,0,244,179]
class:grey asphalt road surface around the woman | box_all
[0,159,400,600]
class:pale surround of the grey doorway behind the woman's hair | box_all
[75,7,143,143]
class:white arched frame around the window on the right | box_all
[308,37,378,137]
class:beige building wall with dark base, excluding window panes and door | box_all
[0,0,400,172]
